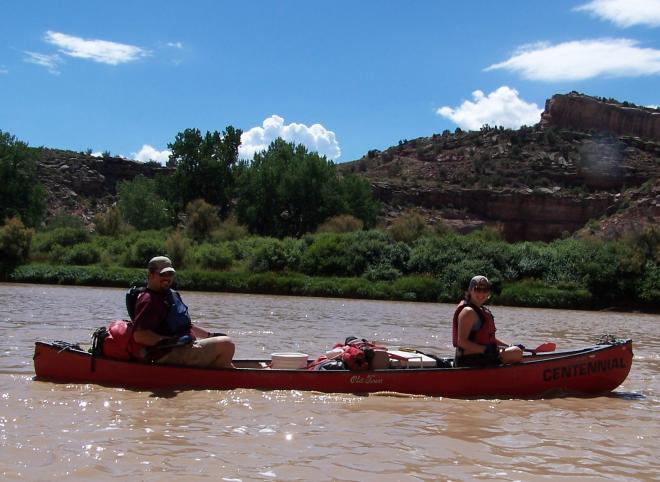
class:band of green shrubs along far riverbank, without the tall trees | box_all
[2,214,660,309]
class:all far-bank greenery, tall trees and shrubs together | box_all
[0,127,660,310]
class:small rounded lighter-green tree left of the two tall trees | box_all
[117,176,172,229]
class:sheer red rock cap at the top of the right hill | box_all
[541,94,660,141]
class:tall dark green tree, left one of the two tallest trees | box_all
[167,126,242,216]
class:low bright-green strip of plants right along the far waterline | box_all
[6,264,657,312]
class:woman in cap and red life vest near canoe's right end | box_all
[452,276,522,367]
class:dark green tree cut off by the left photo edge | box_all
[0,131,46,227]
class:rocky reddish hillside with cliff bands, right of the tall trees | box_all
[340,94,660,241]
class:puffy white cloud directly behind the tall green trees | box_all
[238,115,341,160]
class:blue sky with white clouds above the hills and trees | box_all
[0,0,660,162]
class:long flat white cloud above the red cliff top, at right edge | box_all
[485,39,660,82]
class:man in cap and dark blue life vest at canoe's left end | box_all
[131,256,235,368]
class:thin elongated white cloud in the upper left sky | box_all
[45,30,149,65]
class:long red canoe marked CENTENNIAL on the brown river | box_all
[34,340,633,398]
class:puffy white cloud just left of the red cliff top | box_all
[436,85,543,131]
